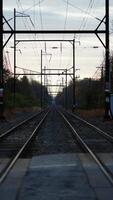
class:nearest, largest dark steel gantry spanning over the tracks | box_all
[0,0,111,119]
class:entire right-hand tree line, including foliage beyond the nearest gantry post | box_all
[55,55,113,109]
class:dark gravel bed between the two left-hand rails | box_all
[0,112,47,158]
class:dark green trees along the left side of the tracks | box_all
[4,70,51,108]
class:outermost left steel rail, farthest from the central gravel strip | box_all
[0,111,43,140]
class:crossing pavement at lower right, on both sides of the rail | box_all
[79,153,113,200]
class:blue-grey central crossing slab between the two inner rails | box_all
[18,154,96,200]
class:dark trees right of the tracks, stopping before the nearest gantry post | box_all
[56,78,104,109]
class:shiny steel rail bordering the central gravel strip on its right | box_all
[58,111,113,185]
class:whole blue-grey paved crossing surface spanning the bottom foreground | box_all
[0,153,113,200]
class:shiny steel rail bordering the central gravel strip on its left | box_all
[0,111,49,184]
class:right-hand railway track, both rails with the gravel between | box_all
[58,110,113,186]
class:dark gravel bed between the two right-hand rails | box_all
[64,112,113,153]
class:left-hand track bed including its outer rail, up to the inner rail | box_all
[0,111,46,157]
